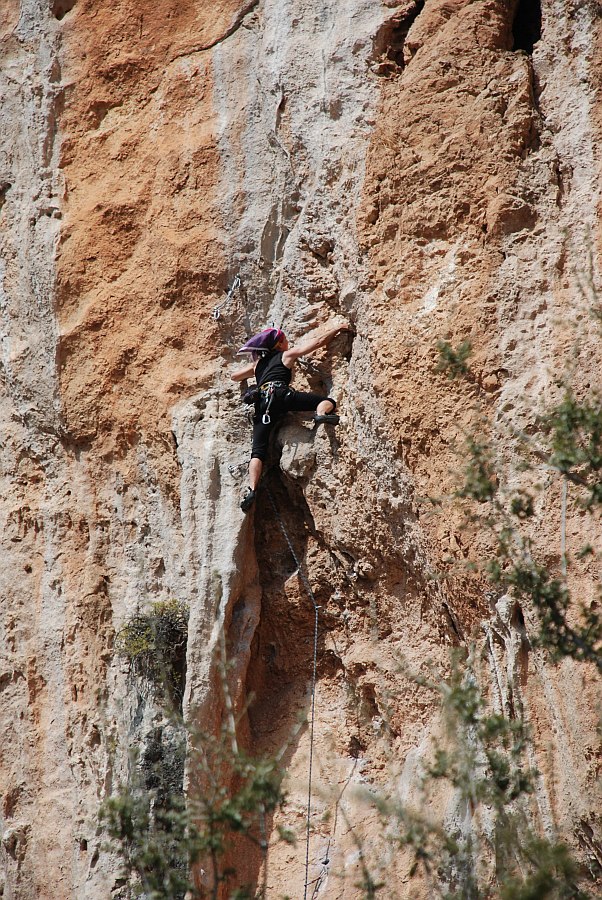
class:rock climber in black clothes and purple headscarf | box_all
[231,324,353,512]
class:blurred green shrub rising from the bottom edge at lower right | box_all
[362,650,589,900]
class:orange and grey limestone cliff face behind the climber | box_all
[0,0,602,900]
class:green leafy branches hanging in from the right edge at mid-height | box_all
[440,342,602,671]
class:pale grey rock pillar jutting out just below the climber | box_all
[174,390,261,877]
